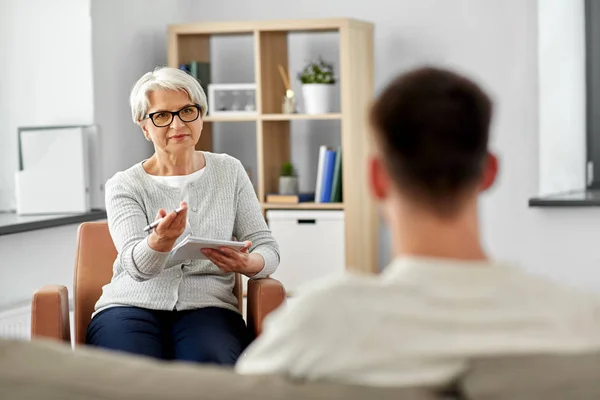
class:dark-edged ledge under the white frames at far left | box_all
[0,210,106,235]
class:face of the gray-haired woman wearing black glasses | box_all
[140,89,203,153]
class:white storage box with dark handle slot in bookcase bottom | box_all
[267,210,345,295]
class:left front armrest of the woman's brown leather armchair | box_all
[31,285,71,343]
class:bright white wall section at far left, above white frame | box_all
[0,0,93,211]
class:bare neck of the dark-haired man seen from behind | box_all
[390,198,487,261]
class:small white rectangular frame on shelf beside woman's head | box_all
[208,83,256,115]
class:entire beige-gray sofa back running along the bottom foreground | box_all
[0,340,600,400]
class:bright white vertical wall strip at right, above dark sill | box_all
[538,0,586,194]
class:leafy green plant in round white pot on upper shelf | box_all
[298,58,336,114]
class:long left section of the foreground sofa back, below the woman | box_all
[0,340,436,400]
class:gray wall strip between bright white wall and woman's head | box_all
[91,0,190,190]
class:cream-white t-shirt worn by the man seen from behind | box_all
[236,257,600,386]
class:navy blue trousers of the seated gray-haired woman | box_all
[86,307,251,365]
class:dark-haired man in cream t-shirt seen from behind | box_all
[236,68,600,386]
